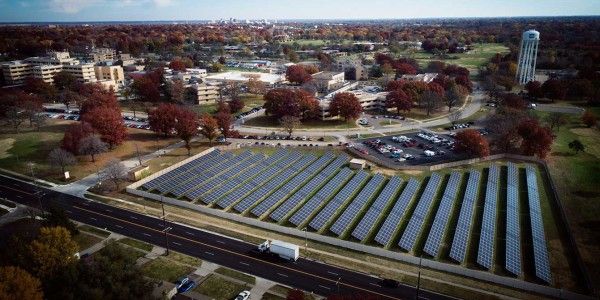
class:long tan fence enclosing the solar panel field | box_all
[126,149,593,299]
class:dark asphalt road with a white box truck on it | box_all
[0,176,450,299]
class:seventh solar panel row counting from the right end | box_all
[375,178,421,246]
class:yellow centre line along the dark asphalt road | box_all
[73,205,401,299]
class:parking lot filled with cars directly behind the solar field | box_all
[355,131,465,165]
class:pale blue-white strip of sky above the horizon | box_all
[0,0,600,22]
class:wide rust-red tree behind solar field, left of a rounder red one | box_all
[264,88,319,120]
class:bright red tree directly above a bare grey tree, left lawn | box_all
[83,107,127,149]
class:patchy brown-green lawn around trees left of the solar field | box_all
[0,119,177,182]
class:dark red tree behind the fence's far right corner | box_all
[517,118,554,159]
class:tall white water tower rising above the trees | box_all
[517,30,540,84]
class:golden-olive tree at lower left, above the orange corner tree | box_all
[28,227,78,278]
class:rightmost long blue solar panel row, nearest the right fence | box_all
[526,165,551,283]
